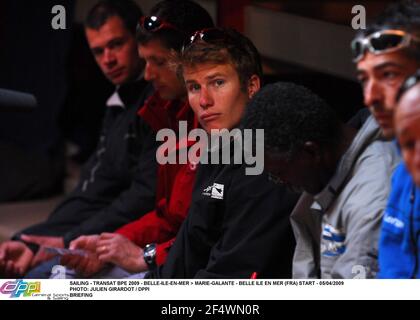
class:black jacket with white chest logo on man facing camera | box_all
[148,140,298,278]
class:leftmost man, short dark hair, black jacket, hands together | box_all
[0,0,157,276]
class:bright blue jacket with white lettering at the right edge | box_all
[378,163,420,278]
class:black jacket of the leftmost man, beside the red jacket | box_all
[14,80,158,245]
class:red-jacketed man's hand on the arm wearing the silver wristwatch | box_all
[96,233,148,273]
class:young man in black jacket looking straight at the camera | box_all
[148,29,296,278]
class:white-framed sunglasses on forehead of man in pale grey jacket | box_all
[351,30,420,62]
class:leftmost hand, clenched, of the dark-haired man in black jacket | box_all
[0,241,34,278]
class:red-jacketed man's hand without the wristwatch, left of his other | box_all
[60,235,105,277]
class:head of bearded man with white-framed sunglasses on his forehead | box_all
[351,1,420,140]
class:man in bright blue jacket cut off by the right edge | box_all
[378,70,420,279]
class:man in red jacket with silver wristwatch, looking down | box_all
[47,1,213,278]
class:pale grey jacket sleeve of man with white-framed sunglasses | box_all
[331,150,393,279]
